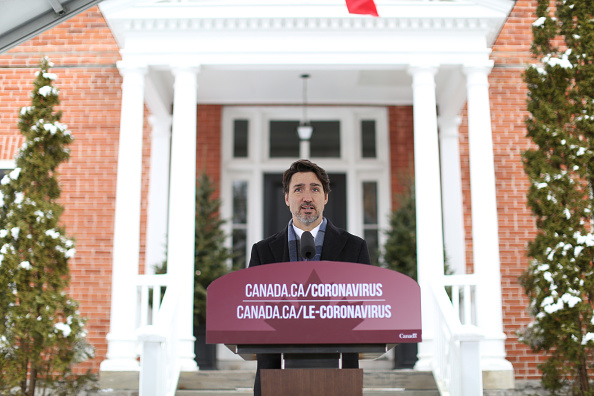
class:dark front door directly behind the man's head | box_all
[263,173,347,238]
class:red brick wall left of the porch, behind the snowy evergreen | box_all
[0,7,121,370]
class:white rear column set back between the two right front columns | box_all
[437,116,466,274]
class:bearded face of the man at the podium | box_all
[285,172,328,231]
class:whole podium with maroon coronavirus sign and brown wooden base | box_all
[206,261,421,396]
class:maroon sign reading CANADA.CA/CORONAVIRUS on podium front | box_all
[206,261,421,345]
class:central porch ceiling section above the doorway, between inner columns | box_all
[176,65,412,105]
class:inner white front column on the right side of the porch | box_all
[409,67,443,371]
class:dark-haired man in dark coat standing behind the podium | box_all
[249,159,371,396]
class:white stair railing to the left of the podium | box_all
[136,274,180,396]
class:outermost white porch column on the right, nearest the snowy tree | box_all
[464,65,513,381]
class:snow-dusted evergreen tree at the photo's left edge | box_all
[0,58,93,396]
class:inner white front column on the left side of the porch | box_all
[167,67,198,371]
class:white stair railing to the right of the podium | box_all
[431,275,484,396]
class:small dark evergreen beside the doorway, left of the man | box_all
[194,171,233,325]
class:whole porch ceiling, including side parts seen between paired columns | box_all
[147,61,466,114]
